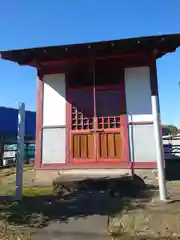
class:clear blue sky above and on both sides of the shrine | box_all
[0,0,180,127]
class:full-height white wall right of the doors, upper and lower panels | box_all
[125,66,156,163]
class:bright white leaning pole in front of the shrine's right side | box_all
[151,96,167,201]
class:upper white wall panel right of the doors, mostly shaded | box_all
[125,67,153,122]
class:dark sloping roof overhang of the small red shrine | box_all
[0,34,180,65]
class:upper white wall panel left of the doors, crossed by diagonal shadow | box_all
[43,74,66,127]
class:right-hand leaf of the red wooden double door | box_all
[96,85,123,162]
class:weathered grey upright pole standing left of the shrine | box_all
[15,103,25,201]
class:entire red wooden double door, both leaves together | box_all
[70,84,123,163]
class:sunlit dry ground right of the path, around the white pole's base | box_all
[108,182,180,239]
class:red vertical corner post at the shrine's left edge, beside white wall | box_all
[35,72,43,168]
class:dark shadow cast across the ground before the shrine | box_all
[0,176,156,227]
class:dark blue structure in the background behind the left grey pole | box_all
[0,107,36,136]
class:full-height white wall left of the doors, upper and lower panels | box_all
[42,74,66,164]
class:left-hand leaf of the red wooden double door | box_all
[70,87,96,163]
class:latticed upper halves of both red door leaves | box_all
[72,88,120,130]
